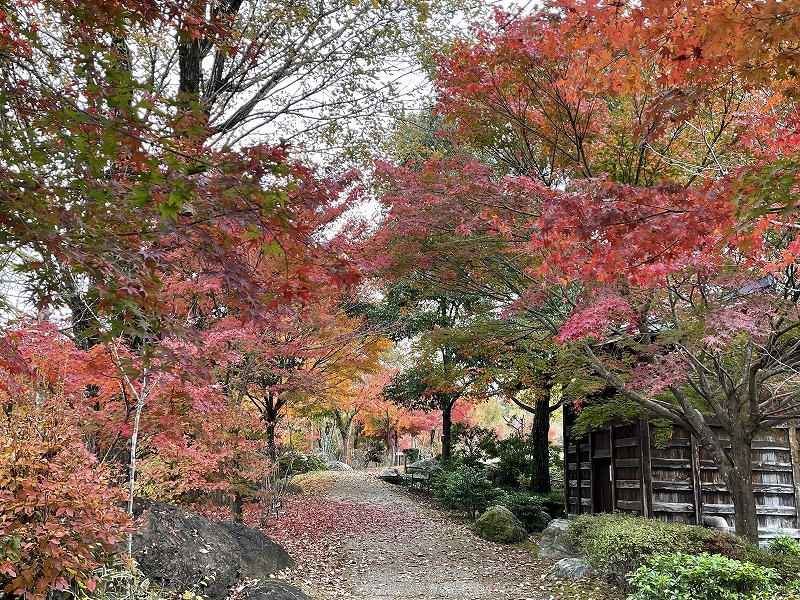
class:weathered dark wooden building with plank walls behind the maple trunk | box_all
[564,411,800,541]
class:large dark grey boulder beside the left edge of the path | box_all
[133,501,293,600]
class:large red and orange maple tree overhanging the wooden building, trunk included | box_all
[376,2,798,539]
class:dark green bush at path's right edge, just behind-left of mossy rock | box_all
[430,464,503,519]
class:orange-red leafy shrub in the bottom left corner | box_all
[0,393,129,600]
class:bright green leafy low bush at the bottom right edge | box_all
[628,552,778,600]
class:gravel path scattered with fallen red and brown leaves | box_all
[269,471,552,600]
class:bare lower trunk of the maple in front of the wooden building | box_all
[720,431,758,544]
